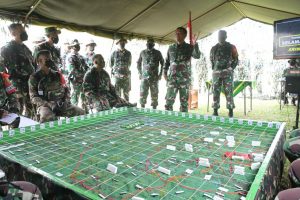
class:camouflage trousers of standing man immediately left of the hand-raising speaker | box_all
[140,79,158,108]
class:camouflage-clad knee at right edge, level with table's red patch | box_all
[283,137,300,162]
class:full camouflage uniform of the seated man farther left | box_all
[28,69,84,123]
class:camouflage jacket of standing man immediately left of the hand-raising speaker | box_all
[137,49,164,80]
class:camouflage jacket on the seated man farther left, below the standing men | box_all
[28,69,70,107]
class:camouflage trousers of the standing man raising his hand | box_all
[165,84,190,112]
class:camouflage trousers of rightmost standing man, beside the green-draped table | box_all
[212,70,235,109]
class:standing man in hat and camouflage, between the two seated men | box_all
[67,39,88,110]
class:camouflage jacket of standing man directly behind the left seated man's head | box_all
[33,41,62,71]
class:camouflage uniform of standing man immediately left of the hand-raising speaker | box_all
[137,49,164,108]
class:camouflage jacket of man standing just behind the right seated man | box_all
[110,49,131,78]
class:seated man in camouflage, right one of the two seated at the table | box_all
[83,54,136,111]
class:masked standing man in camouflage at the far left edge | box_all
[0,24,35,117]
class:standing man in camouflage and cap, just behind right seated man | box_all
[110,38,131,101]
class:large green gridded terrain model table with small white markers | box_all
[0,108,282,200]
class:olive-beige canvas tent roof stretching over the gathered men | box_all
[0,0,300,42]
